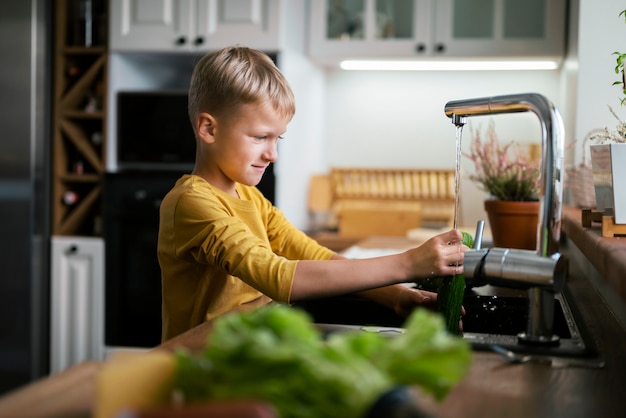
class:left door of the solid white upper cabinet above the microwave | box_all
[109,0,194,51]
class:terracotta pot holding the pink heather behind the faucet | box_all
[485,200,539,250]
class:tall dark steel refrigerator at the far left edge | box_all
[0,0,53,395]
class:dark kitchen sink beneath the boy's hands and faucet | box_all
[297,286,597,357]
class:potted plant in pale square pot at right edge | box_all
[590,10,626,224]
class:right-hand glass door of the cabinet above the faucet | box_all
[435,0,567,57]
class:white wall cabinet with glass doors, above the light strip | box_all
[309,0,567,63]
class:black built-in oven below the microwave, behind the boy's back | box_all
[104,171,182,349]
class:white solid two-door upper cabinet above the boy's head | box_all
[109,0,282,52]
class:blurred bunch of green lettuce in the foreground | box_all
[175,305,471,418]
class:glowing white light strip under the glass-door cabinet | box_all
[339,60,559,71]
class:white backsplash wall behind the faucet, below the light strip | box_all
[326,70,560,225]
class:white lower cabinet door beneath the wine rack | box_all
[50,236,104,373]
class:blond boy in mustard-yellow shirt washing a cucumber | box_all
[158,47,467,341]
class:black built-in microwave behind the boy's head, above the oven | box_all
[115,91,196,171]
